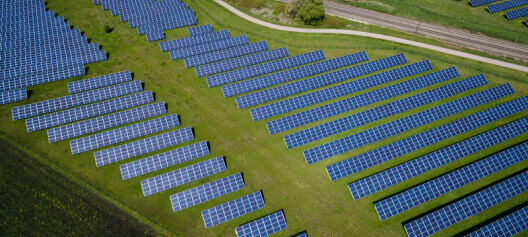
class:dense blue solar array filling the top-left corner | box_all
[0,0,106,104]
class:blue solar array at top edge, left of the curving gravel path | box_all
[94,0,197,42]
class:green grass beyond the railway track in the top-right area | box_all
[334,0,528,44]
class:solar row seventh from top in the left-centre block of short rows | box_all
[121,141,209,180]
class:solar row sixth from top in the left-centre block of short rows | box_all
[94,127,194,166]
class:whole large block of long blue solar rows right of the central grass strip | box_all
[160,21,528,236]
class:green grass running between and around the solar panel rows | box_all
[0,0,528,236]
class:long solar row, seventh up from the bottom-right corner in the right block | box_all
[284,70,478,149]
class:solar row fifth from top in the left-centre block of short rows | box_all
[70,114,180,155]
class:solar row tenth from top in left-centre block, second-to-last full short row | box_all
[202,191,266,229]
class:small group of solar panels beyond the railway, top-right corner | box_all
[469,0,528,20]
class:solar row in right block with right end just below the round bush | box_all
[206,50,325,87]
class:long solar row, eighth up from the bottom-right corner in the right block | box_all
[266,64,452,134]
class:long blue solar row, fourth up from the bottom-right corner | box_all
[348,115,528,202]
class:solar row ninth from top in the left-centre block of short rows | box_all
[170,173,245,212]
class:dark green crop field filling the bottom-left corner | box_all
[0,136,153,236]
